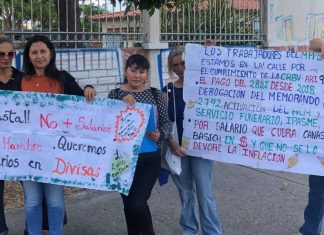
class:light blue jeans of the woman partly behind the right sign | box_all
[172,156,221,235]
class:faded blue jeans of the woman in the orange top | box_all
[23,181,64,235]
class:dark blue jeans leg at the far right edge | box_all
[299,175,324,235]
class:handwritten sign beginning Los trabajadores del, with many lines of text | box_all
[182,44,324,175]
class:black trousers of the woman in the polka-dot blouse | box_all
[121,151,161,235]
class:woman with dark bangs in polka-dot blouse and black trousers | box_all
[108,54,170,235]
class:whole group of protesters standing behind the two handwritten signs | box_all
[0,35,324,235]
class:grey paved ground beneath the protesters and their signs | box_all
[7,163,308,235]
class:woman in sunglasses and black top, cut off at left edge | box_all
[0,35,23,235]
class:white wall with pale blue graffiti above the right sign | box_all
[266,0,324,47]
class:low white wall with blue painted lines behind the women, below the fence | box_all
[13,47,168,98]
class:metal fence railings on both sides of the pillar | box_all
[0,0,264,48]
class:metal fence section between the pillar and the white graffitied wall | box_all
[161,0,264,45]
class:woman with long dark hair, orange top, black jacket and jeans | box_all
[19,35,96,235]
